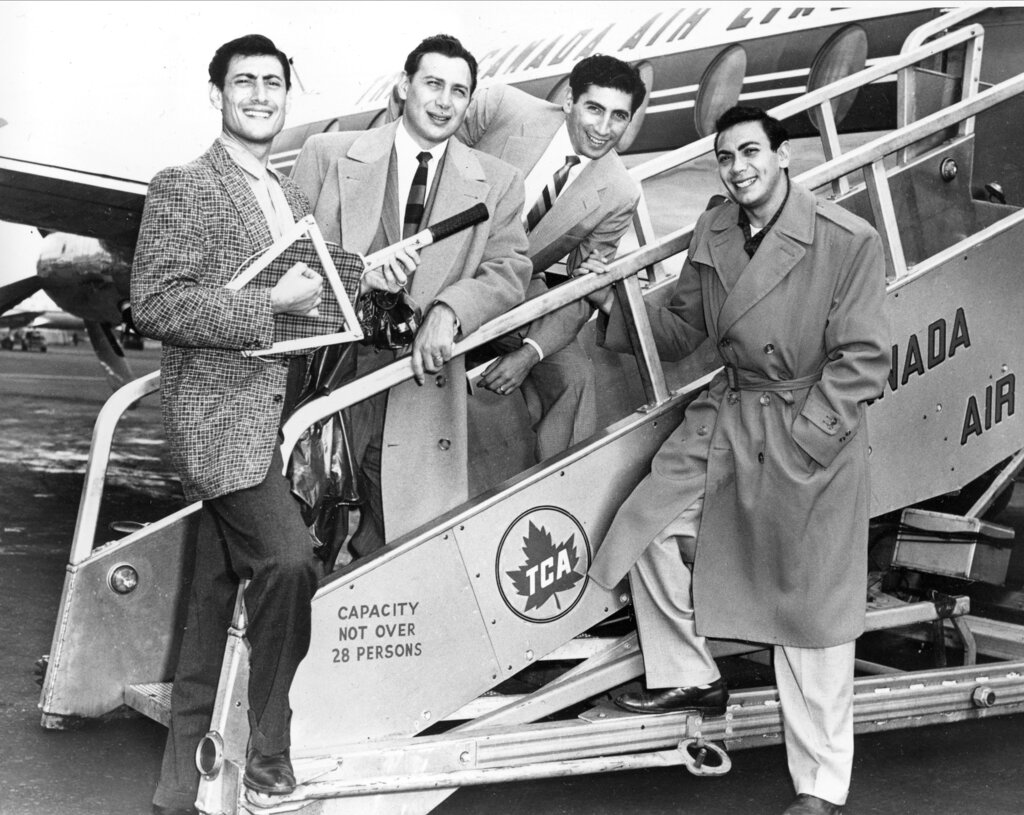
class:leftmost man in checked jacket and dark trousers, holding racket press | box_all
[131,35,364,813]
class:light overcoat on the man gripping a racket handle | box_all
[292,122,530,543]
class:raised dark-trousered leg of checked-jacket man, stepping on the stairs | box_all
[208,448,316,756]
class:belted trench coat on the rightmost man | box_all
[590,185,889,647]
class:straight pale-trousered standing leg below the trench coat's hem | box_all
[775,642,854,805]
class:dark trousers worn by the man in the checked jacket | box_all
[153,447,317,807]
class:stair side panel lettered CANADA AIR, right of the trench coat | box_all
[867,221,1024,515]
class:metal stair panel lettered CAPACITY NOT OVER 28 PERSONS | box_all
[291,531,499,754]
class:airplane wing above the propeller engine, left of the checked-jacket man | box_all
[0,156,147,244]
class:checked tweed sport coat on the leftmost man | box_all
[131,141,357,501]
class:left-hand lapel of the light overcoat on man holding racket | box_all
[338,122,398,253]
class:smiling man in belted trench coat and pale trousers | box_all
[590,108,889,815]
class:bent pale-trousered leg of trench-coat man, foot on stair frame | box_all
[630,499,721,688]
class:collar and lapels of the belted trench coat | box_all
[711,185,814,336]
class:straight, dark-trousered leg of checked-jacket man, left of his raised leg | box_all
[153,506,239,809]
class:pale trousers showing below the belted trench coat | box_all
[630,498,855,805]
